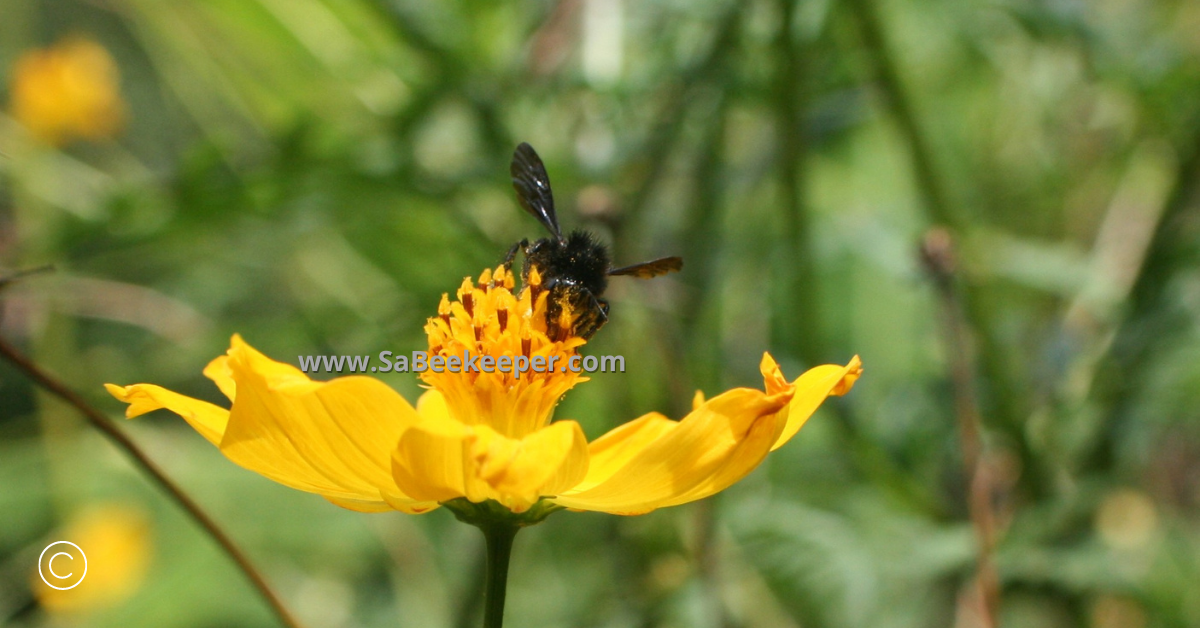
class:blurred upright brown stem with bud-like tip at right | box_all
[920,228,1000,628]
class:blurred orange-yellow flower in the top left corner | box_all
[11,38,125,145]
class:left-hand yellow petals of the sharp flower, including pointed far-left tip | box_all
[106,336,437,513]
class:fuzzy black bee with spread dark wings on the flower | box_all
[504,142,683,340]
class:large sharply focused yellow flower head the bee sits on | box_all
[100,267,862,514]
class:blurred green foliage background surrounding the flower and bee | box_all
[0,0,1200,628]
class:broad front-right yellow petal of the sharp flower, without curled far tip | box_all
[554,388,791,514]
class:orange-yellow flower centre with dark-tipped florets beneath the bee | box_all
[421,265,587,438]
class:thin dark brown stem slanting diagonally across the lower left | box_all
[0,340,301,628]
